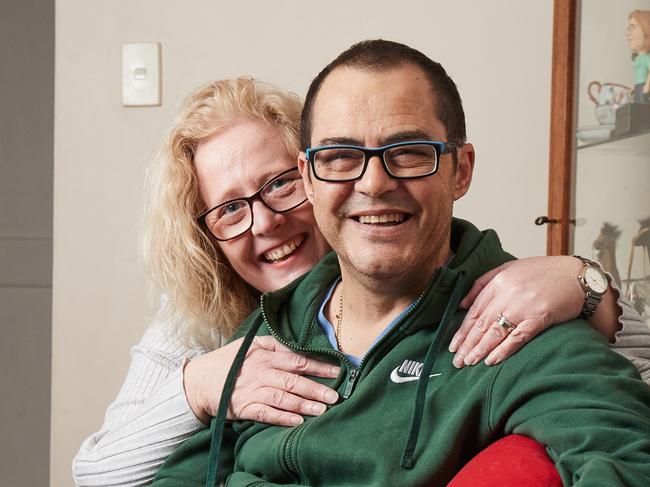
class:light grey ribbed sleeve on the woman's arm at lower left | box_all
[72,314,210,486]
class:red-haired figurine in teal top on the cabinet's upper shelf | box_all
[626,10,650,103]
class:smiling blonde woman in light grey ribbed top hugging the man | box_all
[73,78,647,485]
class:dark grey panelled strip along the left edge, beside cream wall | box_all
[0,0,54,487]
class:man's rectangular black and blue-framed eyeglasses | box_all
[305,140,460,182]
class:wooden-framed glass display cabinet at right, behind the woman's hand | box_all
[547,0,650,320]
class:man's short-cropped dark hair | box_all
[300,39,466,150]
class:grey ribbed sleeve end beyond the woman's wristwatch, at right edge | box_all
[612,290,650,384]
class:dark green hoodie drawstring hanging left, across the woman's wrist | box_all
[205,317,264,487]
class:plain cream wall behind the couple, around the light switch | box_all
[51,0,552,487]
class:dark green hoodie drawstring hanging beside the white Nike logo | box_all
[400,272,465,469]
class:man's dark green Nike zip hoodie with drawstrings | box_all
[154,220,650,487]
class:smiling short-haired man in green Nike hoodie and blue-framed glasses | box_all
[158,41,650,486]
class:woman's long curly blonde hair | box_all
[140,76,302,349]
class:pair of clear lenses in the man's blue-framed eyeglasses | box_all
[313,144,438,181]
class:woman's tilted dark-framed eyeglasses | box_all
[204,169,307,240]
